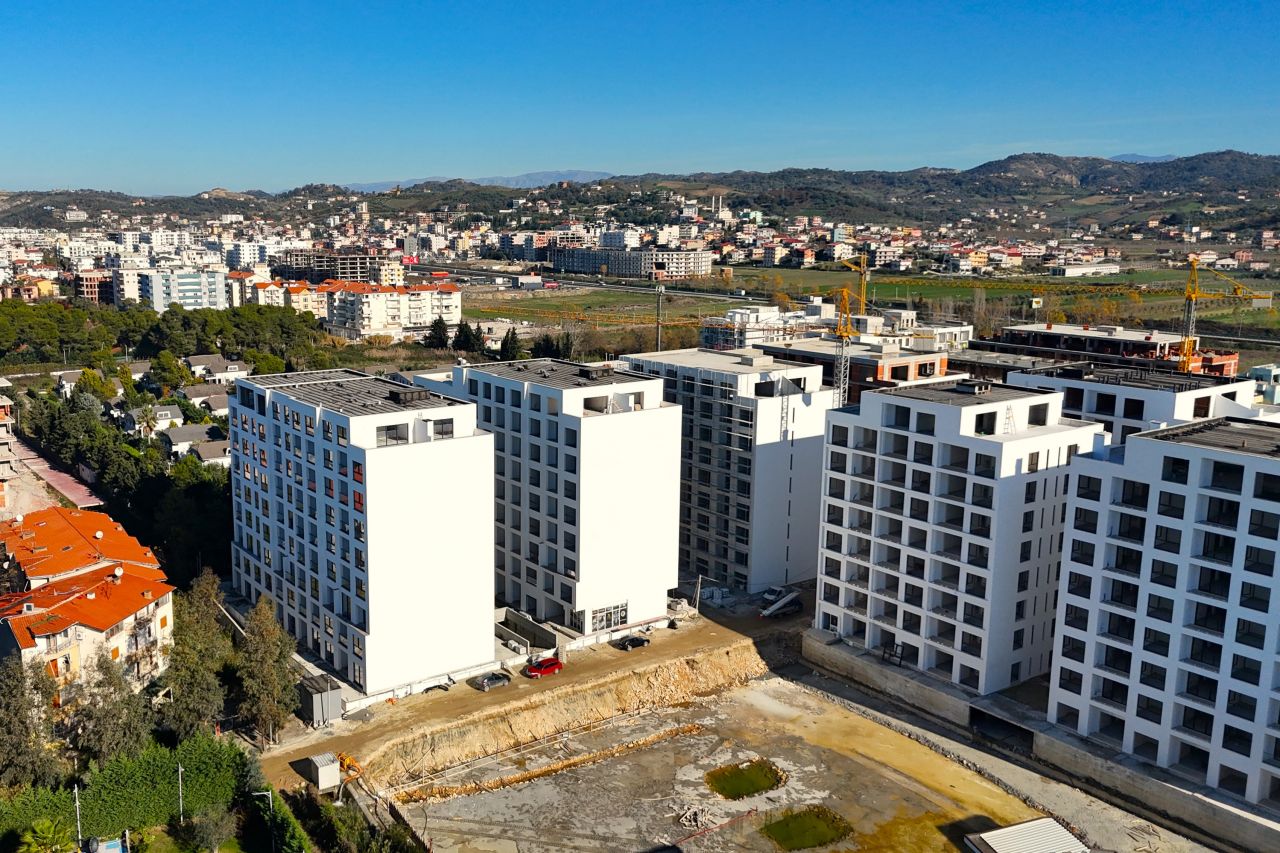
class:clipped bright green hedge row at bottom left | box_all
[0,735,248,849]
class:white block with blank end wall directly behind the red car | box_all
[413,359,680,633]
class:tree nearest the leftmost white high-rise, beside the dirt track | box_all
[239,596,298,742]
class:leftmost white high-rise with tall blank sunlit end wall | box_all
[229,370,494,693]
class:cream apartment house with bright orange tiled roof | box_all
[0,507,173,690]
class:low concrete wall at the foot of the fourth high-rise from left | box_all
[801,628,969,727]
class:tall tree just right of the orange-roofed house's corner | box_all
[163,569,232,739]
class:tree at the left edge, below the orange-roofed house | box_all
[0,652,63,785]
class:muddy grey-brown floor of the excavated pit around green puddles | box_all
[398,675,1038,853]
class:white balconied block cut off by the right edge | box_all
[1048,418,1280,806]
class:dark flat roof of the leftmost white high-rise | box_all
[244,370,463,415]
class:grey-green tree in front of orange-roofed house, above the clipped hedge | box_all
[70,646,152,765]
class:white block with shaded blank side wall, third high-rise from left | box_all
[623,350,836,593]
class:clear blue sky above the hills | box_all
[0,0,1280,193]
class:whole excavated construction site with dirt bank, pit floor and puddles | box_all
[264,607,1207,853]
